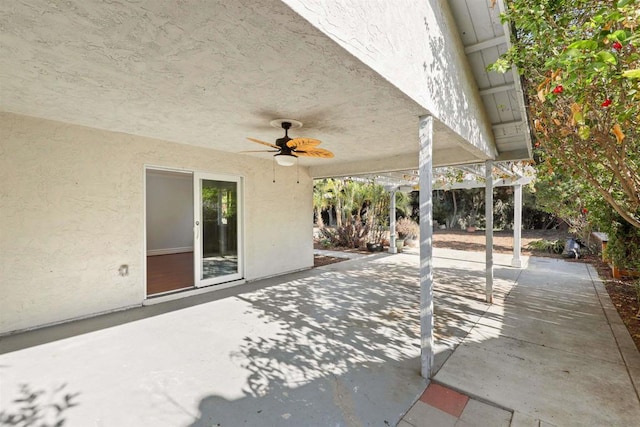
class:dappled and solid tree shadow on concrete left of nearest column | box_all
[185,255,426,426]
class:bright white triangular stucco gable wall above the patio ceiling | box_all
[283,0,495,159]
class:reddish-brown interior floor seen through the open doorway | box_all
[147,252,195,295]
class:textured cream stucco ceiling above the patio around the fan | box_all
[0,0,520,174]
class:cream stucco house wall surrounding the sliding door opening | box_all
[0,113,313,333]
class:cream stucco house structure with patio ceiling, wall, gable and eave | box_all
[0,0,531,342]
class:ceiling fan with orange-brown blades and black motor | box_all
[243,120,333,166]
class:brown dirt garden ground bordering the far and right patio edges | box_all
[315,230,640,350]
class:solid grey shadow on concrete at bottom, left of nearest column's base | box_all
[189,358,426,427]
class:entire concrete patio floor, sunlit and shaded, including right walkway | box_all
[0,249,640,427]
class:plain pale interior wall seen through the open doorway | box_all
[146,169,193,255]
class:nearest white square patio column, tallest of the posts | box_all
[419,116,434,379]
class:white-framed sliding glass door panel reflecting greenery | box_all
[193,173,243,287]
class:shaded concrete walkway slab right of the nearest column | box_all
[435,258,640,426]
